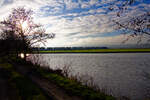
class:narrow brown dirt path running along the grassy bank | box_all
[15,65,81,100]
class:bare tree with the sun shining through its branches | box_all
[0,7,55,58]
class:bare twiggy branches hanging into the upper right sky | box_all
[109,0,150,43]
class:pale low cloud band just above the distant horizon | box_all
[45,35,148,47]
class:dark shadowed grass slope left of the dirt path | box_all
[0,56,48,100]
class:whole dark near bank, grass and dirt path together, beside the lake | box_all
[0,57,115,100]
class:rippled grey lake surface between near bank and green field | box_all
[27,53,150,100]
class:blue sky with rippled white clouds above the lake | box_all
[0,0,150,47]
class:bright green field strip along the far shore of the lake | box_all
[39,48,150,53]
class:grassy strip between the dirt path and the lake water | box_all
[12,56,115,100]
